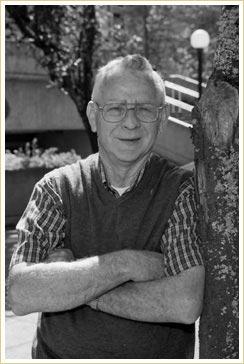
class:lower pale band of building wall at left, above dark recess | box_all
[5,77,84,132]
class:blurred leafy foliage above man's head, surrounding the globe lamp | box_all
[97,5,221,78]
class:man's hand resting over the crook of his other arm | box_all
[127,250,164,282]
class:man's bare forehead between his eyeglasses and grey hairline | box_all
[98,72,159,103]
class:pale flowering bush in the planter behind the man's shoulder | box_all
[5,138,81,171]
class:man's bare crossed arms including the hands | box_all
[9,249,204,324]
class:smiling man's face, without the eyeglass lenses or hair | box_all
[88,74,166,164]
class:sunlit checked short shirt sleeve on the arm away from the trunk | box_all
[10,177,65,267]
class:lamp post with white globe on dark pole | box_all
[191,29,210,99]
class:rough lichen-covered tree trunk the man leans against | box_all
[193,6,239,359]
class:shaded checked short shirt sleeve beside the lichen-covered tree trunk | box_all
[161,178,203,276]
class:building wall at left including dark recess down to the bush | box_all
[5,42,91,157]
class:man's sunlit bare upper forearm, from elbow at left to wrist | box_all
[9,251,130,315]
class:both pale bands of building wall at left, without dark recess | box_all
[5,42,84,132]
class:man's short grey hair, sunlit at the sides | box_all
[92,54,165,103]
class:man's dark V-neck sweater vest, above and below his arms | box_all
[33,154,194,359]
